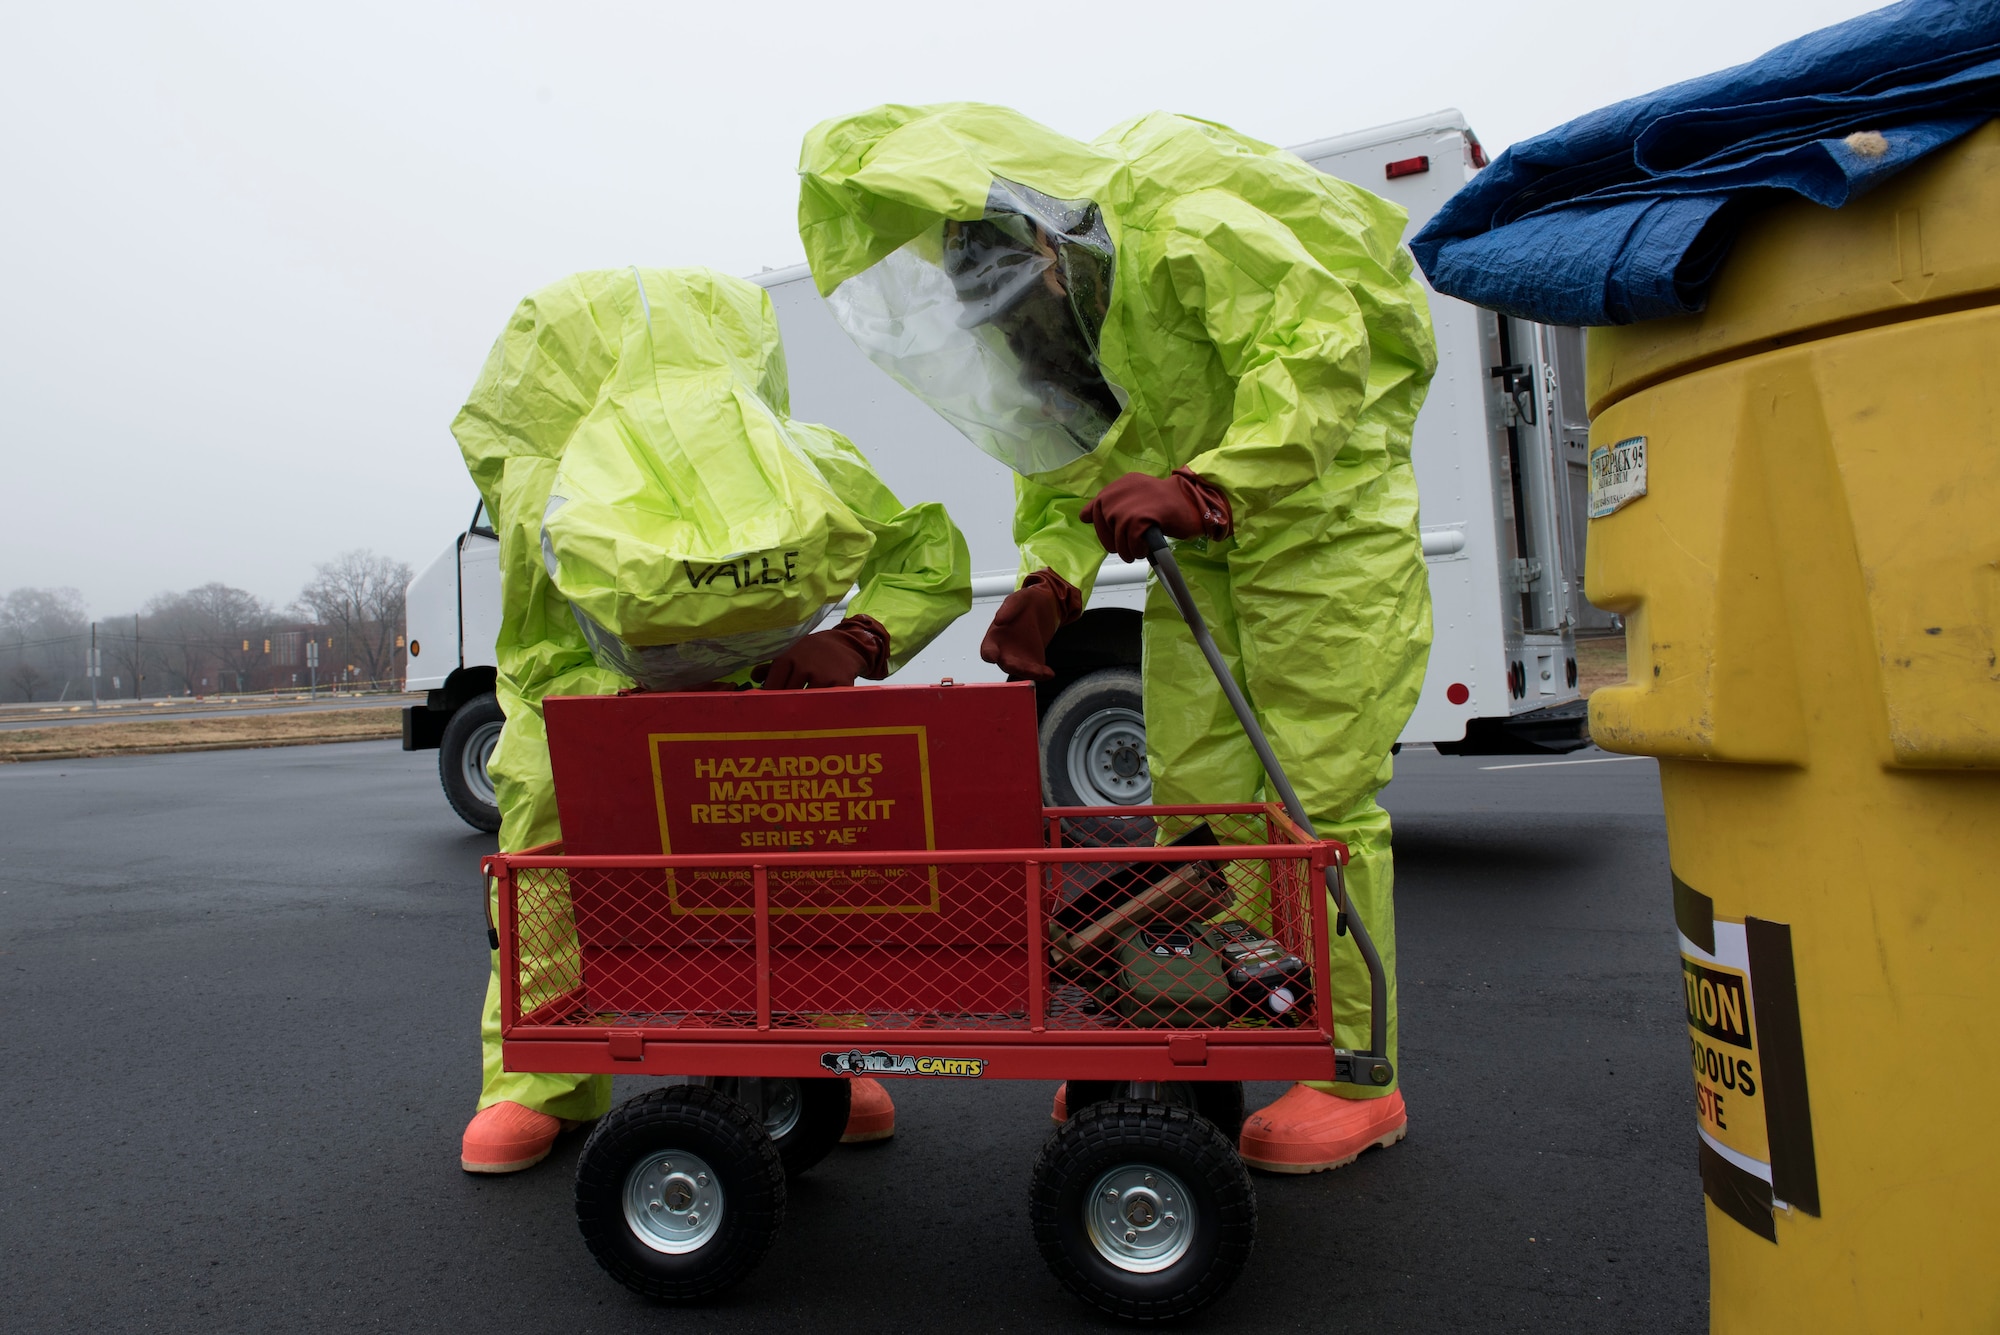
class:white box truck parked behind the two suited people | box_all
[404,110,1608,829]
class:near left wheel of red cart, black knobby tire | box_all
[576,1085,784,1301]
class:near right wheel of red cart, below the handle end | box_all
[1028,1099,1256,1321]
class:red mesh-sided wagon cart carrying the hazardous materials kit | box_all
[484,540,1392,1319]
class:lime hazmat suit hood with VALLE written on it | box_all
[468,270,872,689]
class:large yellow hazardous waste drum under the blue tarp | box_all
[1586,122,2000,1331]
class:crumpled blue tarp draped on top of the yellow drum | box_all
[1410,0,2000,324]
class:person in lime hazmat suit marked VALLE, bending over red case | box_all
[452,270,972,1173]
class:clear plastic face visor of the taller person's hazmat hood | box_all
[826,180,1126,474]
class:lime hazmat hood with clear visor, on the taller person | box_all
[800,104,1126,474]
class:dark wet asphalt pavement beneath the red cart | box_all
[0,741,1708,1335]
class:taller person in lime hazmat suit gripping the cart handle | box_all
[798,104,1436,1173]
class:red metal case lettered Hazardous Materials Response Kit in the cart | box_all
[544,683,1042,1013]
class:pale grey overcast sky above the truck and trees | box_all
[0,0,1874,616]
